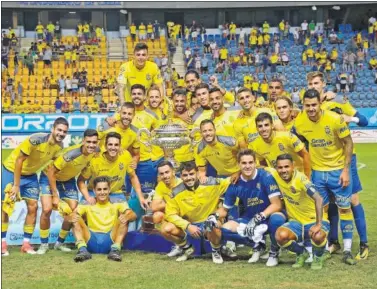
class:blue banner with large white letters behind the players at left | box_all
[1,113,109,134]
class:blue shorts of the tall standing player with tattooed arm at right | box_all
[312,169,352,209]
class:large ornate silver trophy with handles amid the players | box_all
[138,120,199,168]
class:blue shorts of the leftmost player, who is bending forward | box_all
[1,166,39,201]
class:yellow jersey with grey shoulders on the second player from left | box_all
[45,144,94,182]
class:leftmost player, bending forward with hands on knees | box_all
[1,117,68,256]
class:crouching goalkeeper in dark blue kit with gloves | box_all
[207,149,286,267]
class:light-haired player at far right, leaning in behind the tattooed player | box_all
[307,72,369,260]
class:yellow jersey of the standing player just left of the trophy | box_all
[131,108,159,162]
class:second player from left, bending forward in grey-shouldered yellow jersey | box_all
[37,129,98,254]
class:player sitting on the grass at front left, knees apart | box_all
[66,176,136,262]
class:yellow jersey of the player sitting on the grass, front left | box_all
[76,202,129,233]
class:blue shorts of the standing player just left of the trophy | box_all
[126,160,157,193]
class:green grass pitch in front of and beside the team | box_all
[2,144,377,289]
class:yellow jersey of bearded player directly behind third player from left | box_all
[97,121,140,151]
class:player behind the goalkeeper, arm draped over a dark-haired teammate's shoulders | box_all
[233,87,284,148]
